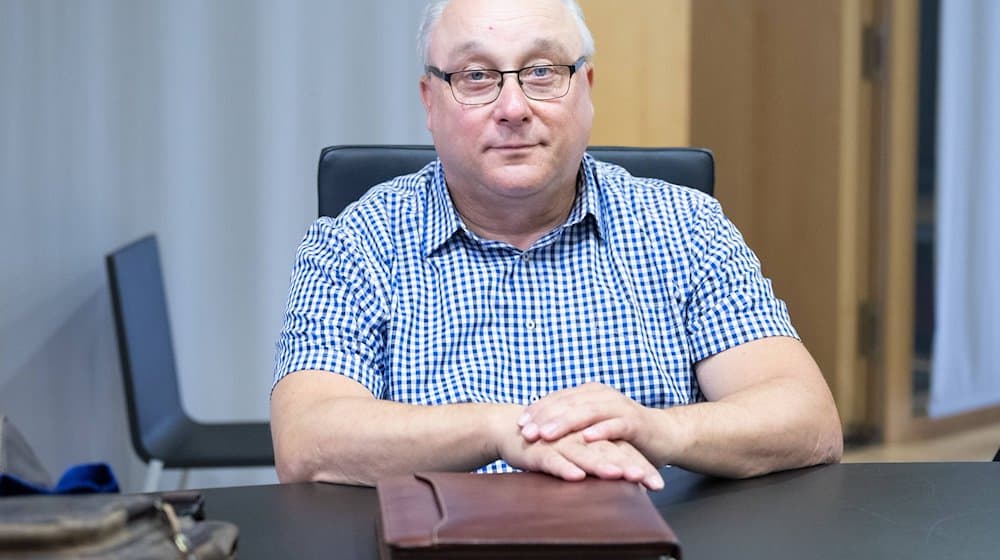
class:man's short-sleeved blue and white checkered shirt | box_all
[274,155,797,472]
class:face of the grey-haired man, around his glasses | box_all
[420,0,594,205]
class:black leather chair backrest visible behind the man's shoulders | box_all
[318,146,715,216]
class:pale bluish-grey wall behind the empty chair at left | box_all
[0,0,430,490]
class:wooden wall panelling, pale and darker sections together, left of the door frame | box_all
[581,0,873,424]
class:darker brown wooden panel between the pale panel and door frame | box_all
[690,0,870,424]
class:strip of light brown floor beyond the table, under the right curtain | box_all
[843,424,1000,463]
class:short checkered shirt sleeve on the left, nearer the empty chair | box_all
[271,218,387,398]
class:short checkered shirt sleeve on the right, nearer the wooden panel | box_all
[686,199,798,362]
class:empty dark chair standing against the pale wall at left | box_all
[107,235,274,492]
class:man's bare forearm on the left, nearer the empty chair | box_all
[272,373,521,485]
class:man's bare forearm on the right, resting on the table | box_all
[640,378,843,478]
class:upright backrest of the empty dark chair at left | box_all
[106,235,188,462]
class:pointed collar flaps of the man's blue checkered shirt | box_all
[423,154,606,258]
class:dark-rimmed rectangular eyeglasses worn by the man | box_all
[424,56,587,105]
